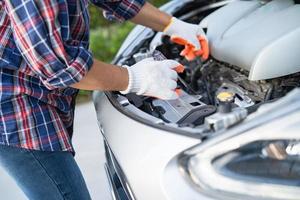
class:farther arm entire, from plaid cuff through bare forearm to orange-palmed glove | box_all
[91,0,209,60]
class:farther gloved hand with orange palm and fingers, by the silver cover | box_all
[164,17,209,61]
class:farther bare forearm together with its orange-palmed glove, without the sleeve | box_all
[131,3,209,60]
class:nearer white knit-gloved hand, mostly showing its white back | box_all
[121,58,183,100]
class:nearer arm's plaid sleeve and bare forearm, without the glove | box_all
[5,0,128,91]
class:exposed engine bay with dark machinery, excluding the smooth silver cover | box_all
[113,0,300,134]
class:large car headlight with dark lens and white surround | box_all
[179,91,300,199]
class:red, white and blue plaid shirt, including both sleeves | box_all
[0,0,145,151]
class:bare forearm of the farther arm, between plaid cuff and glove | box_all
[131,3,172,31]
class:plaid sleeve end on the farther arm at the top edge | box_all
[90,0,146,22]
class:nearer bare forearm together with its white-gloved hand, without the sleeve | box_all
[71,58,183,99]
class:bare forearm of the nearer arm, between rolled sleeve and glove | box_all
[71,59,128,91]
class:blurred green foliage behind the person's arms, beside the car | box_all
[77,0,168,103]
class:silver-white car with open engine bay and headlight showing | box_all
[94,0,300,200]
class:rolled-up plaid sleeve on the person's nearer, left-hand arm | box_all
[5,0,93,90]
